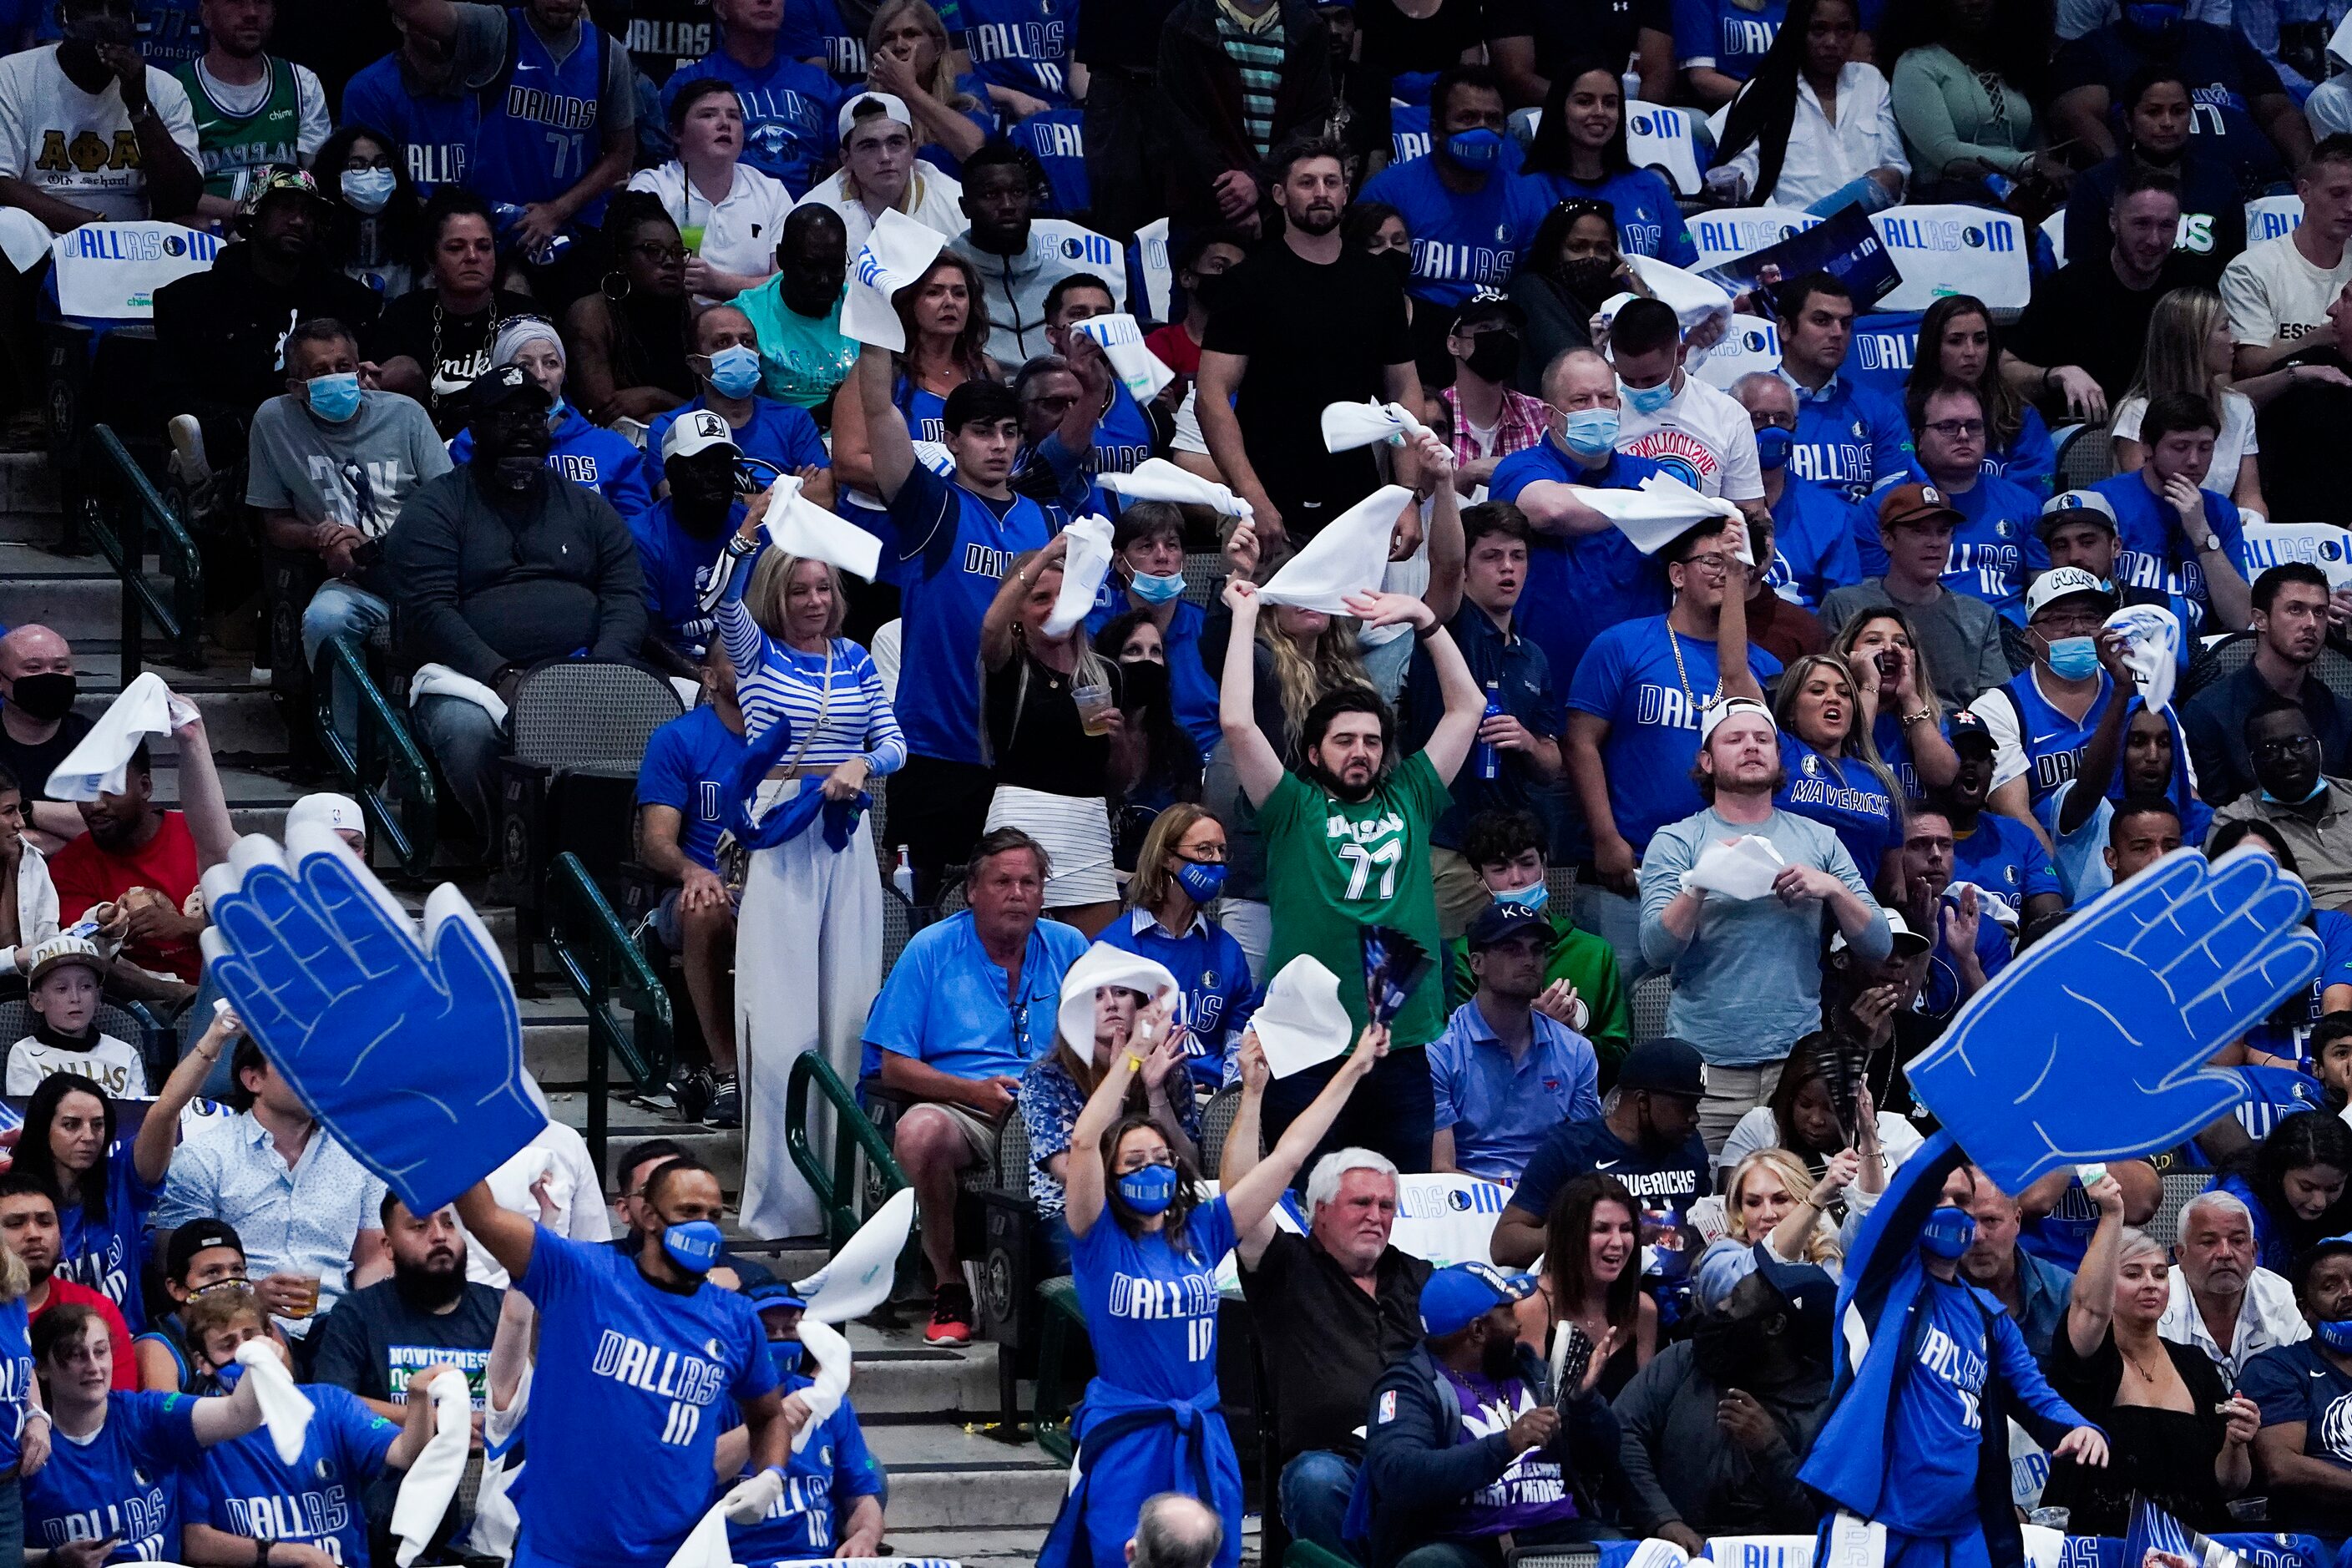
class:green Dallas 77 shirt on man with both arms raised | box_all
[1258,752,1454,1046]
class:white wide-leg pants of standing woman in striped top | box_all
[736,778,882,1239]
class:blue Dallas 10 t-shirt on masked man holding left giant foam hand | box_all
[515,1225,776,1568]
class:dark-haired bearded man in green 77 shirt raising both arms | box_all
[1218,579,1486,1171]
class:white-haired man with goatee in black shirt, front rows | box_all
[1218,1142,1430,1554]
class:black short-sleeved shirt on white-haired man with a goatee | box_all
[1242,1216,1430,1462]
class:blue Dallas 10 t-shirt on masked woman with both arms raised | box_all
[1070,1194,1240,1406]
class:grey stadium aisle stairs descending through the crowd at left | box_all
[0,439,1065,1565]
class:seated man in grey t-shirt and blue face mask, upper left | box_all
[245,315,449,741]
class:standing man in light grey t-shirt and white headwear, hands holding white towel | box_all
[1641,698,1891,1154]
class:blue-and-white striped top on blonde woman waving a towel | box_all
[706,541,906,778]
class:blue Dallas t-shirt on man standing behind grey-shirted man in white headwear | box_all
[1569,616,1780,856]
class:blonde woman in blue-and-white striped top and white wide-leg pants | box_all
[703,509,906,1237]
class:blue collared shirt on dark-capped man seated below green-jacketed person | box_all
[1430,999,1601,1182]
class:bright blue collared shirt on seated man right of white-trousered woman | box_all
[861,910,1089,1079]
